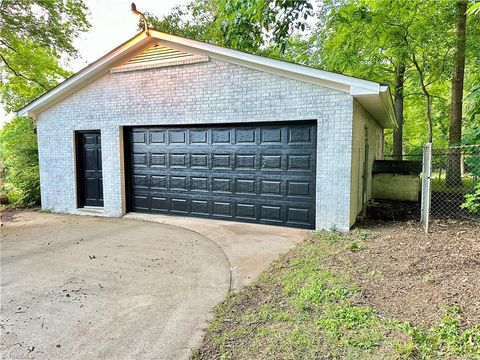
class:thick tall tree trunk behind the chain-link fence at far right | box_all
[446,0,467,186]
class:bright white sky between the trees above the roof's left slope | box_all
[0,0,189,127]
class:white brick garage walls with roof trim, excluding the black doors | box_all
[19,32,394,230]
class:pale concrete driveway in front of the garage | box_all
[0,212,306,359]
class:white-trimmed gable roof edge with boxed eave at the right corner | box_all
[17,30,397,128]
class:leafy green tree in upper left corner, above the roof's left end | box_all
[0,0,90,111]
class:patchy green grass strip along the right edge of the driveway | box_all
[194,231,480,359]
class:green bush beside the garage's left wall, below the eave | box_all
[0,117,40,206]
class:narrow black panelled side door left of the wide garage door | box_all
[77,131,103,207]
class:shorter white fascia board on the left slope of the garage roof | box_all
[17,32,151,118]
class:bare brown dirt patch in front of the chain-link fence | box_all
[344,220,480,327]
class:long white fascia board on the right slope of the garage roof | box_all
[151,30,380,95]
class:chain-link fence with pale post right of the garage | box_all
[421,144,480,231]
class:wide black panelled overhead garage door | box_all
[126,122,316,228]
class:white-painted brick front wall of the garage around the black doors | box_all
[38,59,353,230]
